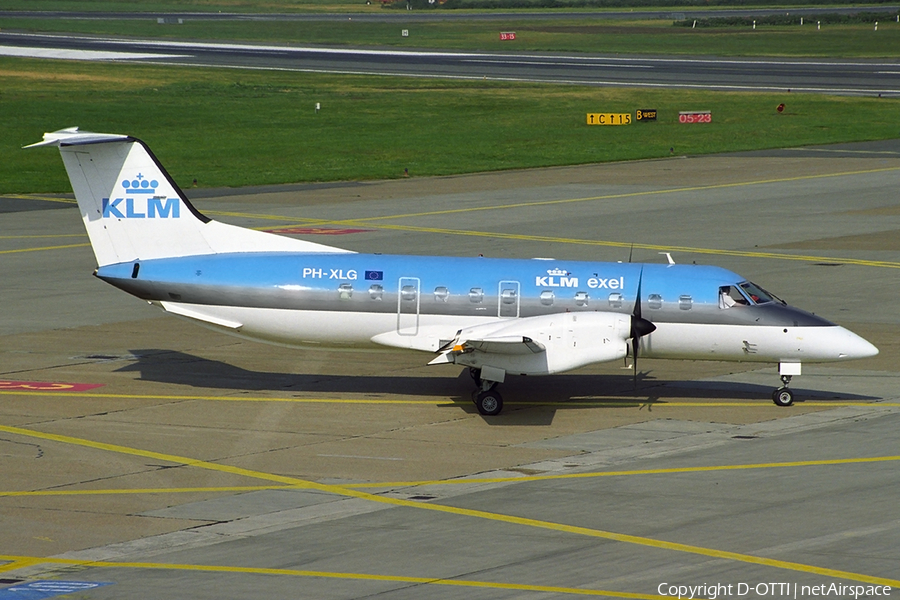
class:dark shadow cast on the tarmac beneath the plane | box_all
[117,349,878,425]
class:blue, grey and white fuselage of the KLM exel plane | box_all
[97,252,868,362]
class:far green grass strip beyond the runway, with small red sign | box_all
[0,17,900,58]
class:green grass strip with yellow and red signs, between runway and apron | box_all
[0,58,900,193]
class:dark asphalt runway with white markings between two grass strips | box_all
[0,32,900,96]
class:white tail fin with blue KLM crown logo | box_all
[26,127,347,266]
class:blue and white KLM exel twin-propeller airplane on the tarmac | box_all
[26,127,878,416]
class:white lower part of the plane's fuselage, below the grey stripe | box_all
[158,302,871,363]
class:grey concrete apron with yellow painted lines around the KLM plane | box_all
[0,146,900,600]
